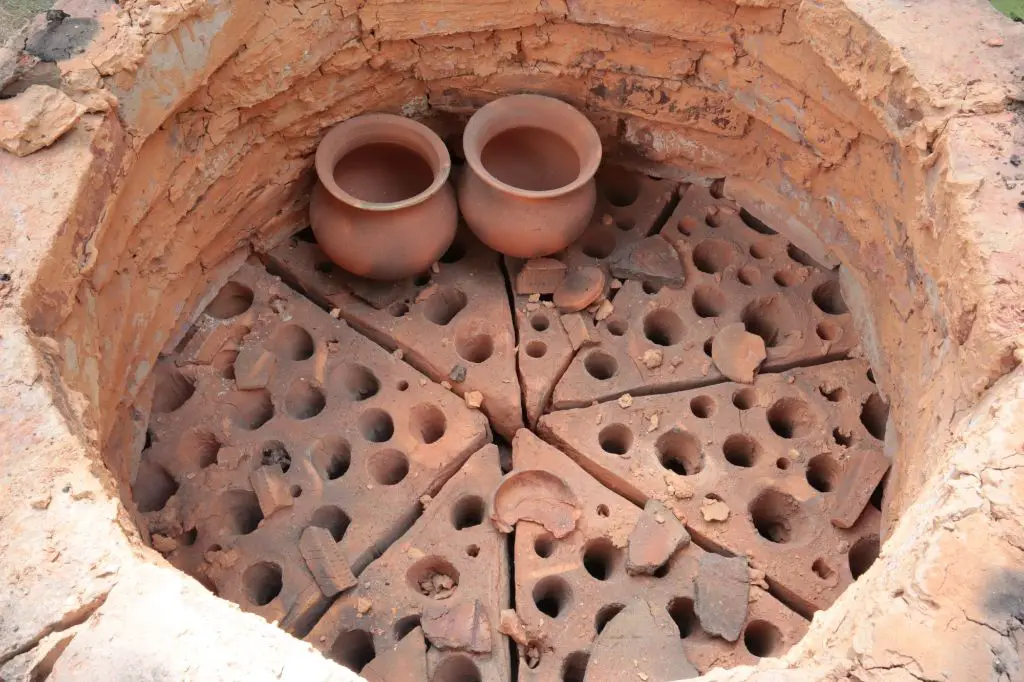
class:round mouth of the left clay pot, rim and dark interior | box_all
[315,114,452,211]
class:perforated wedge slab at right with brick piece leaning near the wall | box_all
[539,360,888,612]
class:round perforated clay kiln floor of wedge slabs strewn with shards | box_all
[133,169,889,681]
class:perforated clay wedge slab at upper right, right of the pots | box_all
[553,186,857,410]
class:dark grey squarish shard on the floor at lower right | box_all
[694,553,751,642]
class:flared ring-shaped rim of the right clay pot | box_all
[463,94,602,199]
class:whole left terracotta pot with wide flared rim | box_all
[309,114,458,280]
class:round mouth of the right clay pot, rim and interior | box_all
[463,95,601,199]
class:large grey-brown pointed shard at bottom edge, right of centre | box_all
[584,600,698,682]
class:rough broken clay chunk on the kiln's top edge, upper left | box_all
[0,85,85,157]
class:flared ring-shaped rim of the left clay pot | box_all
[313,114,452,212]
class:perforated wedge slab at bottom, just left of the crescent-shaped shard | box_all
[306,445,510,682]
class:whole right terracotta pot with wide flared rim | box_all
[459,94,601,258]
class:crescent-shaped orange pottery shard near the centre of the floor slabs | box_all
[490,470,581,538]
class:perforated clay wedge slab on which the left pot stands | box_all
[269,228,523,438]
